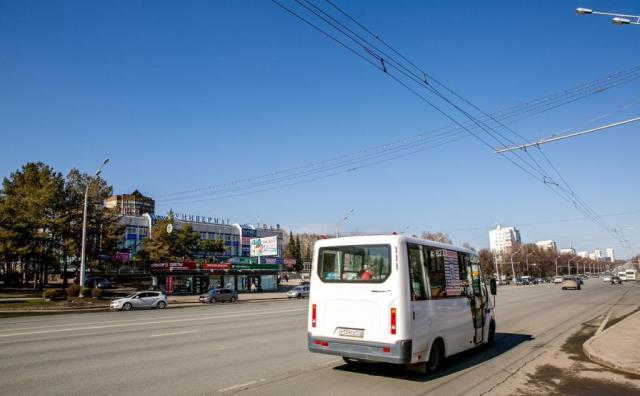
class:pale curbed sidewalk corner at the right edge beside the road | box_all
[582,312,640,375]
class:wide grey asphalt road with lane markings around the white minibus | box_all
[0,279,640,396]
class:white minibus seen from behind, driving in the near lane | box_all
[308,235,496,371]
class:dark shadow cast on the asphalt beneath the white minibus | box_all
[334,333,534,382]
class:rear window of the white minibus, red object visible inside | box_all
[318,245,391,283]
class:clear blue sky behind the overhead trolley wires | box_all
[0,0,640,255]
